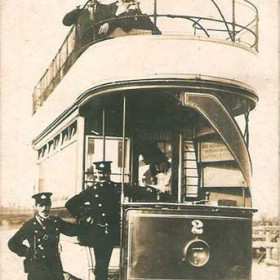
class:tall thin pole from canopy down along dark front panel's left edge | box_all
[120,95,126,279]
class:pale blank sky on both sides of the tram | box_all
[0,0,279,219]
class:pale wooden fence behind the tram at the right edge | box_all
[253,226,280,266]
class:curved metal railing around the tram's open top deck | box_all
[33,0,258,113]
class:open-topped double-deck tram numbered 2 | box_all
[30,0,258,280]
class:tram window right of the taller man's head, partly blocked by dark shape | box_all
[138,142,172,194]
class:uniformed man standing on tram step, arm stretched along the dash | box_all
[65,161,158,280]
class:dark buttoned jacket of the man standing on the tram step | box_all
[65,181,158,246]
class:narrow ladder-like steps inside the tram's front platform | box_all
[183,140,199,200]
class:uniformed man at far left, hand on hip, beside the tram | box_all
[8,192,81,280]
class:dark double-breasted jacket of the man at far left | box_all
[8,216,80,273]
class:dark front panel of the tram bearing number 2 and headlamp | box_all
[125,209,252,279]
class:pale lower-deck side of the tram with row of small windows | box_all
[35,121,80,208]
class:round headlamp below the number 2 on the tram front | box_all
[184,239,209,267]
